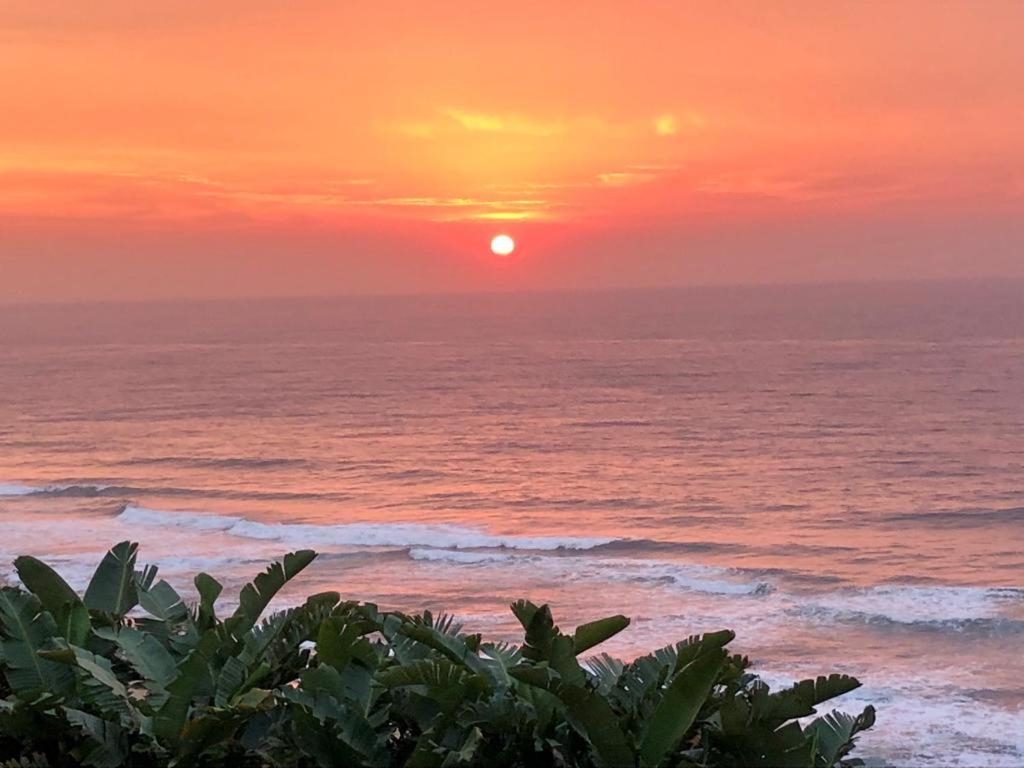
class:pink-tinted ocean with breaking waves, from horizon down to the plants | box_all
[0,281,1024,766]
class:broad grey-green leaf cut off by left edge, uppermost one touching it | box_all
[0,587,74,699]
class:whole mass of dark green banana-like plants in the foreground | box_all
[0,542,874,768]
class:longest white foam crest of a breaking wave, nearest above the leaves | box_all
[119,505,616,550]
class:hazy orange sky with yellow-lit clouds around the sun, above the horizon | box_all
[0,0,1024,301]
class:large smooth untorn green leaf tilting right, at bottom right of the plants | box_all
[640,648,726,768]
